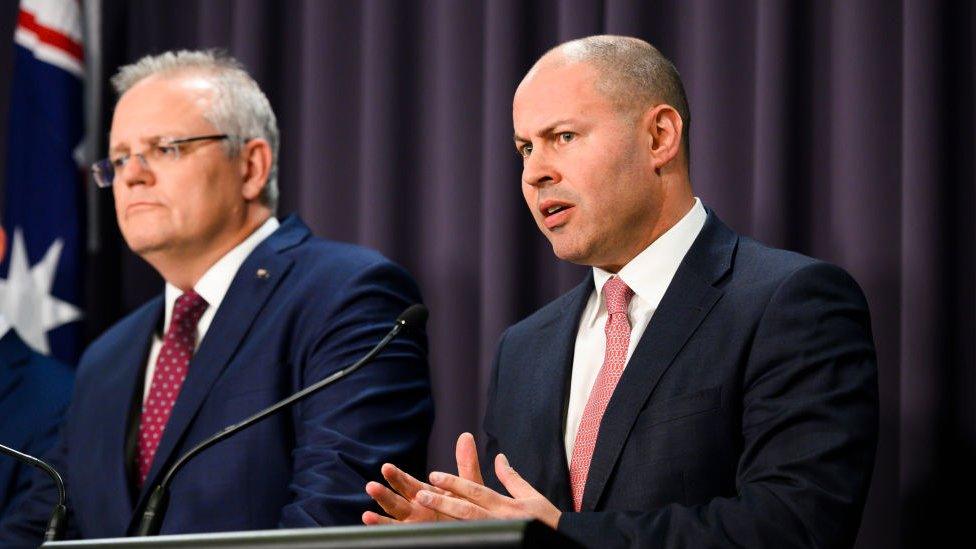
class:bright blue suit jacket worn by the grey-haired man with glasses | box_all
[0,217,433,546]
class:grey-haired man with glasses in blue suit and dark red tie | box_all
[0,51,432,547]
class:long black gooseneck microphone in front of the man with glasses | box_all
[135,303,429,536]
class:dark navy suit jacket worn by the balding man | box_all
[483,212,878,548]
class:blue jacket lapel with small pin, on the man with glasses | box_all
[137,217,309,508]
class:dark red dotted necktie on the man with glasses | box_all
[137,290,207,486]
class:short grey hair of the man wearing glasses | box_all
[112,50,279,213]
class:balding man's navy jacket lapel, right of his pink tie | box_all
[582,212,738,511]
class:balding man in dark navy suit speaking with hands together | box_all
[363,36,878,548]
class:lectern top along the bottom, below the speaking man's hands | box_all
[41,520,579,549]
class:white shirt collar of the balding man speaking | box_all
[586,197,708,325]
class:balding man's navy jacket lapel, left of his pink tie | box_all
[520,272,593,510]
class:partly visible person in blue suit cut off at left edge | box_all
[0,227,74,520]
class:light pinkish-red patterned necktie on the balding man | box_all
[569,276,634,511]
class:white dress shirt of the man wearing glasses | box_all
[142,217,279,400]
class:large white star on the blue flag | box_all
[0,227,81,355]
